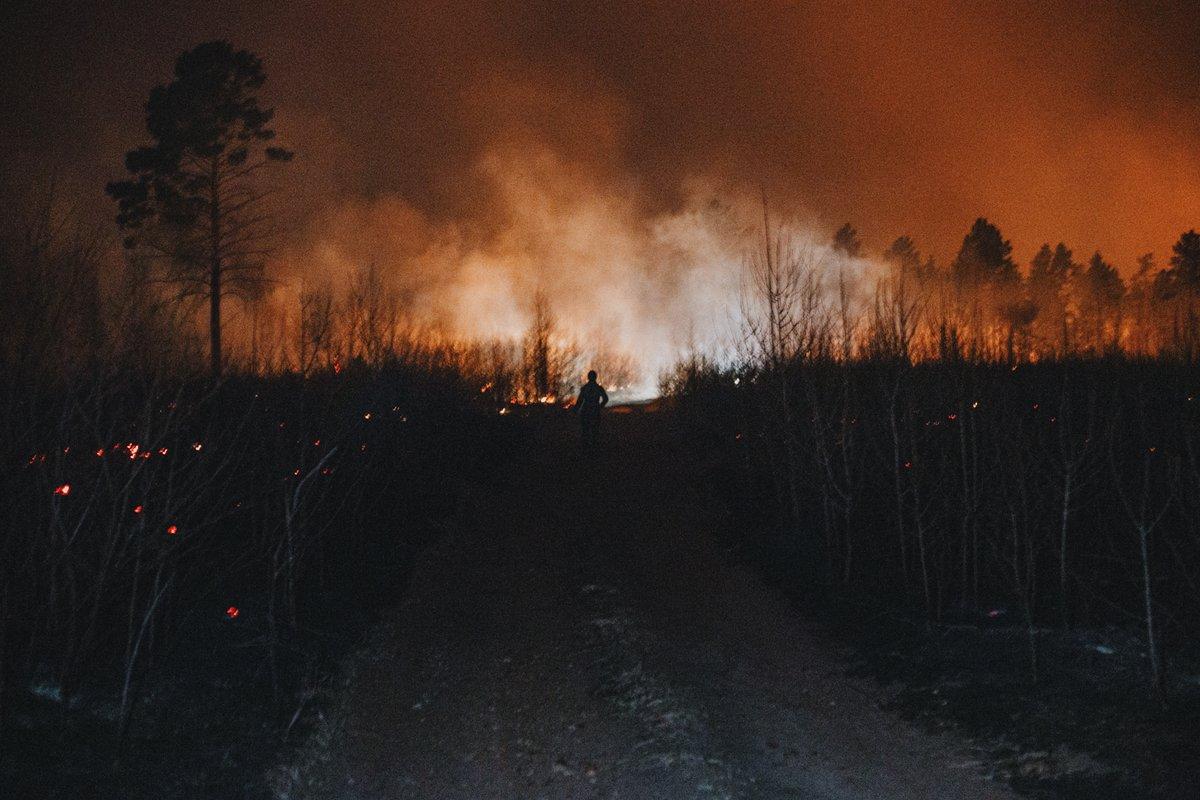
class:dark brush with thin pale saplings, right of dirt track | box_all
[670,357,1200,796]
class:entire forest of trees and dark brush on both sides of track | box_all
[0,31,1200,796]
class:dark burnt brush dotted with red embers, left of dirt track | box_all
[0,361,498,796]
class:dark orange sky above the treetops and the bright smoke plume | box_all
[0,0,1200,269]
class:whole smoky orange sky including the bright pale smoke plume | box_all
[0,0,1200,386]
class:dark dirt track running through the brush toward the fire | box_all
[290,414,1012,800]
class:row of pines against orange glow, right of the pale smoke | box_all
[840,217,1200,362]
